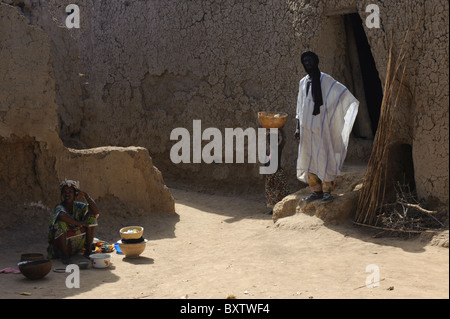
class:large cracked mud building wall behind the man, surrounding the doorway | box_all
[2,0,449,210]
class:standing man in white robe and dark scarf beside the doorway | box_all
[295,51,359,202]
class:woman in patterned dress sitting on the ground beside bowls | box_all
[48,180,99,264]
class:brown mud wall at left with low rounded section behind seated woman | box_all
[0,2,175,219]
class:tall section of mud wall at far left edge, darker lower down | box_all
[0,3,63,209]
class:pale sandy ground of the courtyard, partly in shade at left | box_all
[0,189,449,299]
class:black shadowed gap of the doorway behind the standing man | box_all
[344,13,383,137]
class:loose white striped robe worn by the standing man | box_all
[296,73,359,183]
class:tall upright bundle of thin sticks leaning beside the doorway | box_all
[355,19,421,226]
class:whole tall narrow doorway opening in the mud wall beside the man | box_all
[343,13,383,139]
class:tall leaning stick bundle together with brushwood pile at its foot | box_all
[354,14,444,233]
